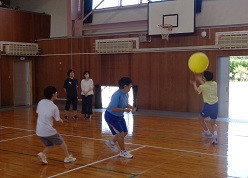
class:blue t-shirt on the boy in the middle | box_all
[107,89,128,117]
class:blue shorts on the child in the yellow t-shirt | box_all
[200,103,218,119]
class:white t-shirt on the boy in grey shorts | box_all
[36,99,60,137]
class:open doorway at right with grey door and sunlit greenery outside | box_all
[217,56,248,120]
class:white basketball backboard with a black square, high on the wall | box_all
[148,0,195,35]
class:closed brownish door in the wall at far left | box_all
[14,61,30,106]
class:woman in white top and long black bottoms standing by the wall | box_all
[81,71,94,119]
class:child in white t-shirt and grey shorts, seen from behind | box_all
[36,86,76,164]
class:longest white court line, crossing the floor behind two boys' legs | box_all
[0,126,227,157]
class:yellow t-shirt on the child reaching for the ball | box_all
[197,81,218,105]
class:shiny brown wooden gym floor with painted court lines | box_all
[0,108,248,178]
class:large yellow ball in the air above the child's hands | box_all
[188,52,209,74]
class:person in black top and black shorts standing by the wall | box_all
[64,69,78,120]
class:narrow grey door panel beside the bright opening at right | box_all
[217,57,230,117]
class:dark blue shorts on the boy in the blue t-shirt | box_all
[104,111,127,135]
